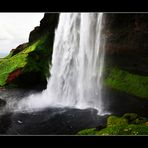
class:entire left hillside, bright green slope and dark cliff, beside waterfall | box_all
[0,13,59,88]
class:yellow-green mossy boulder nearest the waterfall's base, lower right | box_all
[107,116,128,127]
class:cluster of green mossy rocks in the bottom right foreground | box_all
[78,113,148,135]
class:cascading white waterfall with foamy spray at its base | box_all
[19,13,104,113]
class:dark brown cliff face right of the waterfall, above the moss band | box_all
[105,13,148,75]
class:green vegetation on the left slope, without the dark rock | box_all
[0,34,52,86]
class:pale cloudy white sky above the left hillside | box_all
[0,13,44,57]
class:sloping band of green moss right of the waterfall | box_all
[105,68,148,99]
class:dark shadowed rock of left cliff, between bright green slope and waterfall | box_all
[15,13,59,89]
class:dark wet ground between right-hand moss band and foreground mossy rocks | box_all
[103,88,148,117]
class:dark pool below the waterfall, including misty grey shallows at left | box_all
[0,90,107,135]
